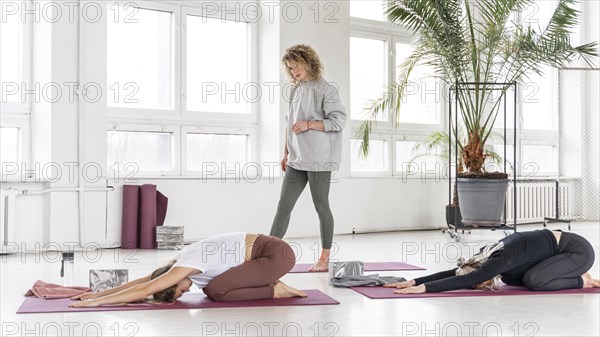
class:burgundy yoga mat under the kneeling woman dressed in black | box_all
[352,285,600,299]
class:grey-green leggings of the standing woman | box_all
[270,166,333,249]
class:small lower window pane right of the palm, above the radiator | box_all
[521,145,558,176]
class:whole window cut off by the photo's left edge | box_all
[0,0,31,179]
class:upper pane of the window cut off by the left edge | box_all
[0,3,24,102]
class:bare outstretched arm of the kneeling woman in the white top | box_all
[69,267,195,307]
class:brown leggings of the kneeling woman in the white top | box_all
[202,235,296,302]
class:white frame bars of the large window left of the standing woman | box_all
[105,0,263,178]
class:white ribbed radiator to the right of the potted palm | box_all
[506,180,574,224]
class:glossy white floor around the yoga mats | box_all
[0,223,600,336]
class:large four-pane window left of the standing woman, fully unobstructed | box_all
[107,3,255,176]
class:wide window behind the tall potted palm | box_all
[350,0,558,178]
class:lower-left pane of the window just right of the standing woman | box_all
[351,139,389,172]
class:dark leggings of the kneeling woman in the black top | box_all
[523,232,595,291]
